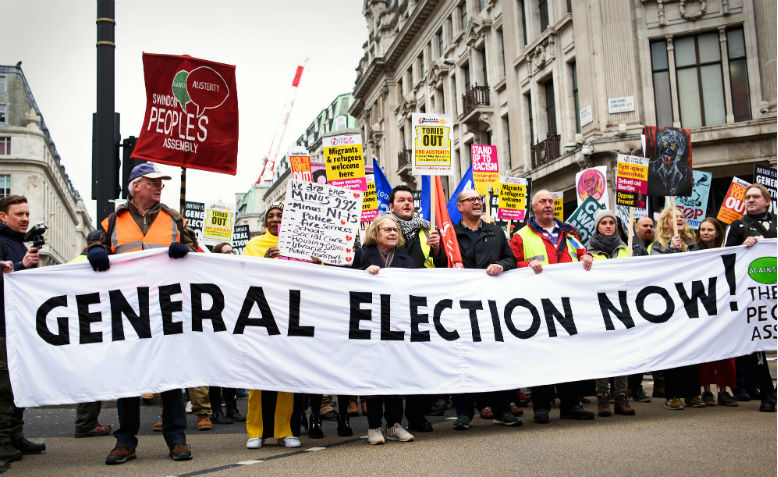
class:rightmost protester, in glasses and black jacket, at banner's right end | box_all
[724,184,776,412]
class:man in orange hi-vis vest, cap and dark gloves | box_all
[87,162,196,465]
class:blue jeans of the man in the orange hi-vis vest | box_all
[113,389,186,449]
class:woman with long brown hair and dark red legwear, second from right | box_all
[697,217,738,407]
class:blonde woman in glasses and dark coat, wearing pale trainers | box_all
[352,215,417,445]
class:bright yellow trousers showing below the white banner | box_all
[246,389,294,439]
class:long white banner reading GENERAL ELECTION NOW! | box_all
[5,239,776,407]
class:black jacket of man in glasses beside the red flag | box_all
[454,220,516,271]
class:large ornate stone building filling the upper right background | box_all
[351,0,776,215]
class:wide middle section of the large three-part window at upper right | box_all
[673,31,726,128]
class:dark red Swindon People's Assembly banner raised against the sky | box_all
[132,53,238,175]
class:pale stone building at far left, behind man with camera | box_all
[0,66,93,265]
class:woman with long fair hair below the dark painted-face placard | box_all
[650,207,705,411]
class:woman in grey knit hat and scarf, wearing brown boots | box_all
[586,209,635,417]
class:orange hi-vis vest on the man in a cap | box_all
[101,208,181,253]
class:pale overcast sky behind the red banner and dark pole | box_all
[0,0,367,220]
